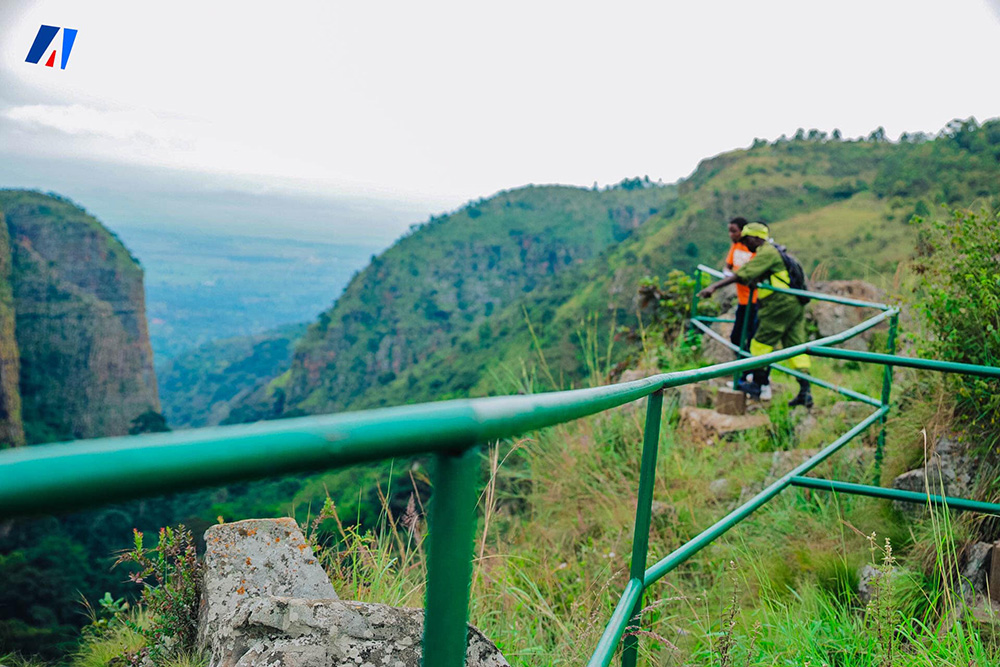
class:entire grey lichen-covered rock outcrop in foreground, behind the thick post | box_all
[198,519,507,667]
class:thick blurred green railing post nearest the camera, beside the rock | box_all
[422,447,479,667]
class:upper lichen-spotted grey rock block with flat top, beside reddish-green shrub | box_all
[198,519,337,653]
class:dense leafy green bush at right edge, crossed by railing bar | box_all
[915,209,1000,445]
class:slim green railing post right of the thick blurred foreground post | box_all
[622,389,663,667]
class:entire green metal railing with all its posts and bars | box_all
[0,267,1000,667]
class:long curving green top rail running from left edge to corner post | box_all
[0,311,894,518]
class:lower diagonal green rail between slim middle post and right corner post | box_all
[643,407,889,588]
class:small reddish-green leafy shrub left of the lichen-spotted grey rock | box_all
[116,526,202,667]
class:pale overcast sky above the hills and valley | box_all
[0,0,1000,241]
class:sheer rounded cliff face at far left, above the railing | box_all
[0,190,159,444]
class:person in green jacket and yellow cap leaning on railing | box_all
[698,222,813,408]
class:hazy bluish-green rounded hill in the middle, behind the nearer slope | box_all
[230,179,675,421]
